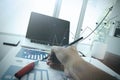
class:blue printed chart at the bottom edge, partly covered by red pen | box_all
[1,65,49,80]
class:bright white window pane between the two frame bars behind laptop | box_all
[59,0,83,42]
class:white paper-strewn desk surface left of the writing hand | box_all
[0,34,66,80]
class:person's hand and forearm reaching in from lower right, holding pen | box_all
[47,46,117,80]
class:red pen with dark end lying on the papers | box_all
[14,60,39,79]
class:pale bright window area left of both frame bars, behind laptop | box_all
[0,0,55,35]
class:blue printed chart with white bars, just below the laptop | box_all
[16,48,48,61]
